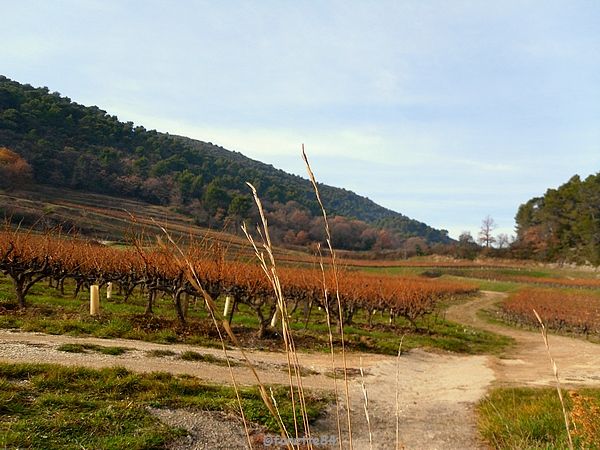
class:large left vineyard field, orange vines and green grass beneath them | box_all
[0,229,510,354]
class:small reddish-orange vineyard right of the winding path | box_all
[501,289,600,336]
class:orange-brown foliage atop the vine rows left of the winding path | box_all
[0,231,475,322]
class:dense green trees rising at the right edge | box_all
[516,173,600,265]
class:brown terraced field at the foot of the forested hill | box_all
[0,186,312,261]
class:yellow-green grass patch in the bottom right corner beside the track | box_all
[477,388,600,449]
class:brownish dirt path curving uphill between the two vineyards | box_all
[446,292,600,386]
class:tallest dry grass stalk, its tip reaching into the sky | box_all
[302,144,353,450]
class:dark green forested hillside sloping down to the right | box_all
[0,76,450,250]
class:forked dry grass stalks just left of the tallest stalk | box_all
[242,183,312,448]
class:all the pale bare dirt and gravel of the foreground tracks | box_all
[0,292,600,450]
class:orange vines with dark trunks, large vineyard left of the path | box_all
[0,231,475,337]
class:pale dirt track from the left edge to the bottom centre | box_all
[0,331,493,450]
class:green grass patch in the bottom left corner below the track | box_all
[0,364,328,449]
